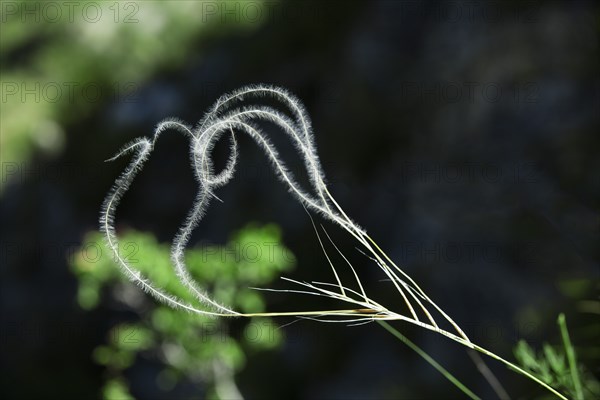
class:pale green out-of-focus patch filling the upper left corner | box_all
[0,0,263,188]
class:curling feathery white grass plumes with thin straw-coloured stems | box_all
[101,85,565,398]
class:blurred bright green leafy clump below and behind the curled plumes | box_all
[72,224,295,399]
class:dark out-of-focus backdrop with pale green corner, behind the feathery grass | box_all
[0,0,600,399]
